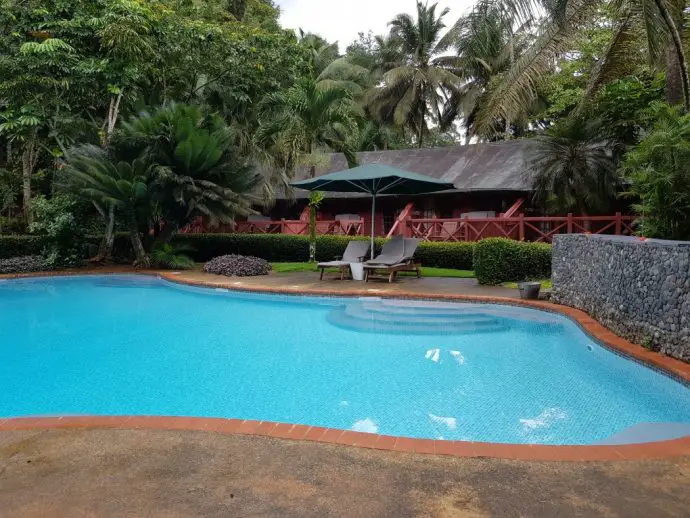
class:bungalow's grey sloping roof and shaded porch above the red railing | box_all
[265,140,531,235]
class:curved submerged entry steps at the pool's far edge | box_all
[328,301,507,334]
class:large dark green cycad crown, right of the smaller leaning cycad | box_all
[113,105,263,235]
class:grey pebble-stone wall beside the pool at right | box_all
[552,235,690,361]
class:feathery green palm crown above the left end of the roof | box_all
[256,77,357,177]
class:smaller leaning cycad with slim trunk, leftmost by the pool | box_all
[64,144,153,267]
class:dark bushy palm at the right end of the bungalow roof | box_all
[526,117,621,214]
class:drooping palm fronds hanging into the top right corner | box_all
[477,0,690,136]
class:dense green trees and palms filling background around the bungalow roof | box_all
[0,0,690,269]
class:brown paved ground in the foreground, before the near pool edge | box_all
[0,430,690,518]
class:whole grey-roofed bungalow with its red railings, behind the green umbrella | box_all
[187,140,633,241]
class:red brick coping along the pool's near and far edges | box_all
[0,268,690,461]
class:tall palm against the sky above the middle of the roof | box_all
[367,2,461,147]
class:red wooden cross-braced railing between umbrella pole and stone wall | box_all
[403,213,635,243]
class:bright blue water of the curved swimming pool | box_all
[0,276,690,444]
